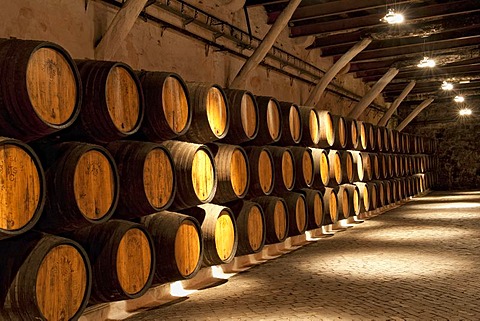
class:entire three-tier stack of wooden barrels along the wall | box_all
[0,39,436,320]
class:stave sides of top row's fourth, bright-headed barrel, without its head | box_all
[178,82,231,144]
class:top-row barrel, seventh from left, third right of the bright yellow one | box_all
[278,102,303,146]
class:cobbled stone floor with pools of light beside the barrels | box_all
[128,191,480,321]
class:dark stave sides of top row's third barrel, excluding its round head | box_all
[137,71,192,143]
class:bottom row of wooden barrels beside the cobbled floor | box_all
[0,170,432,320]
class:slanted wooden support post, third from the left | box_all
[305,38,372,106]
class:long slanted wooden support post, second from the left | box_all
[230,0,302,88]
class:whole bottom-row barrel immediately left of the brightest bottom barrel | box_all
[141,211,203,283]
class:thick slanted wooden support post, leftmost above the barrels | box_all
[95,0,148,60]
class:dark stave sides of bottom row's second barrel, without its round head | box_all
[67,220,156,304]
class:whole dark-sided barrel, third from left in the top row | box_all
[138,71,192,142]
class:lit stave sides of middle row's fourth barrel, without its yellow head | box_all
[161,140,218,210]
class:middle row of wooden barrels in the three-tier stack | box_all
[0,138,431,239]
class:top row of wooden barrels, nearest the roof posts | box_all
[0,39,435,154]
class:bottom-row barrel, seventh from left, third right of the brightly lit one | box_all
[282,192,308,236]
